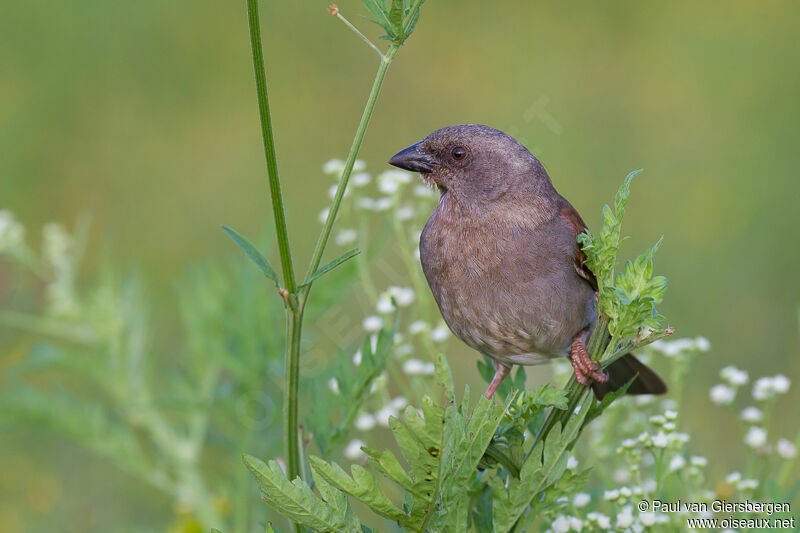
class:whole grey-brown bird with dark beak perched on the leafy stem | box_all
[389,124,667,398]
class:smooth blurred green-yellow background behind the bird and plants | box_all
[0,0,800,531]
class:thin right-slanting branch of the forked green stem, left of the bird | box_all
[300,43,398,305]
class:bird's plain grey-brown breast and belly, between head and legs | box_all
[420,198,594,364]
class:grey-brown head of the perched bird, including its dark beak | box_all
[389,124,549,201]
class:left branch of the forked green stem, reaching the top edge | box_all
[247,0,297,294]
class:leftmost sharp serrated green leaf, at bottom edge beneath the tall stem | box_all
[244,455,361,533]
